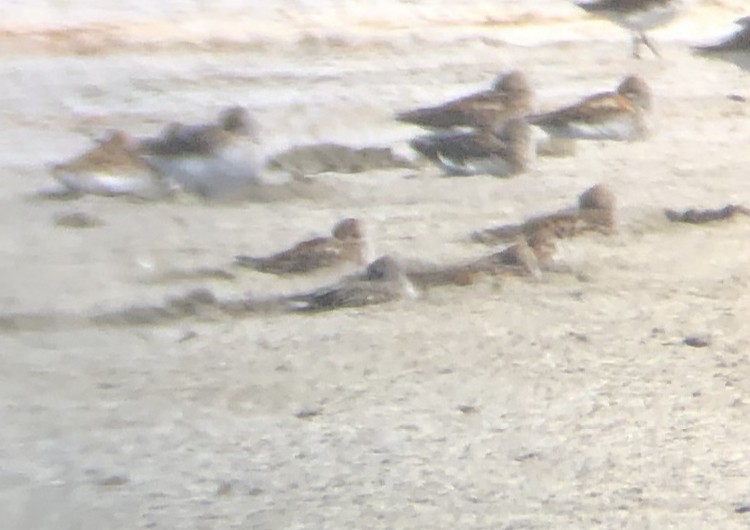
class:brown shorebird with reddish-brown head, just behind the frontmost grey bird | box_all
[235,219,367,275]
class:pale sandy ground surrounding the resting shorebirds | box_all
[0,1,750,529]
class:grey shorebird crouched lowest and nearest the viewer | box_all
[286,256,416,311]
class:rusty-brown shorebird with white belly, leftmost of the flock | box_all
[50,131,167,199]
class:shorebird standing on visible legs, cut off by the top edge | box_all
[577,0,684,58]
